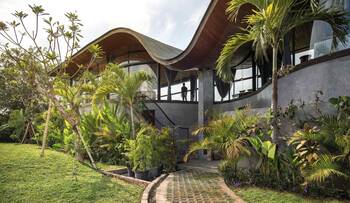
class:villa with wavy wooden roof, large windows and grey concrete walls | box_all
[63,0,350,159]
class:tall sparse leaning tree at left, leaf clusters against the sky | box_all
[0,5,102,169]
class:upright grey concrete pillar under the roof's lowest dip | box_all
[198,69,214,159]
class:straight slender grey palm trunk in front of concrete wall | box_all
[271,46,278,143]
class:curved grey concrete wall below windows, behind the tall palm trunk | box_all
[213,56,350,112]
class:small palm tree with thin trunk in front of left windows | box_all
[93,63,153,138]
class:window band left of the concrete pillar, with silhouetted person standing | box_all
[111,51,198,102]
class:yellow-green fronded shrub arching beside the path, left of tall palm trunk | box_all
[184,109,267,161]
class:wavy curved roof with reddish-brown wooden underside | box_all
[68,0,251,72]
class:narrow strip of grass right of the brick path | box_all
[233,187,350,203]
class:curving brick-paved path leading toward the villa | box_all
[152,169,243,203]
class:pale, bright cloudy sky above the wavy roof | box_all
[0,0,210,49]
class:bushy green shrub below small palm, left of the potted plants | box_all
[81,103,131,164]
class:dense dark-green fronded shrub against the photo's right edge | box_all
[289,96,350,198]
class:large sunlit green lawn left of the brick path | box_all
[0,143,143,203]
